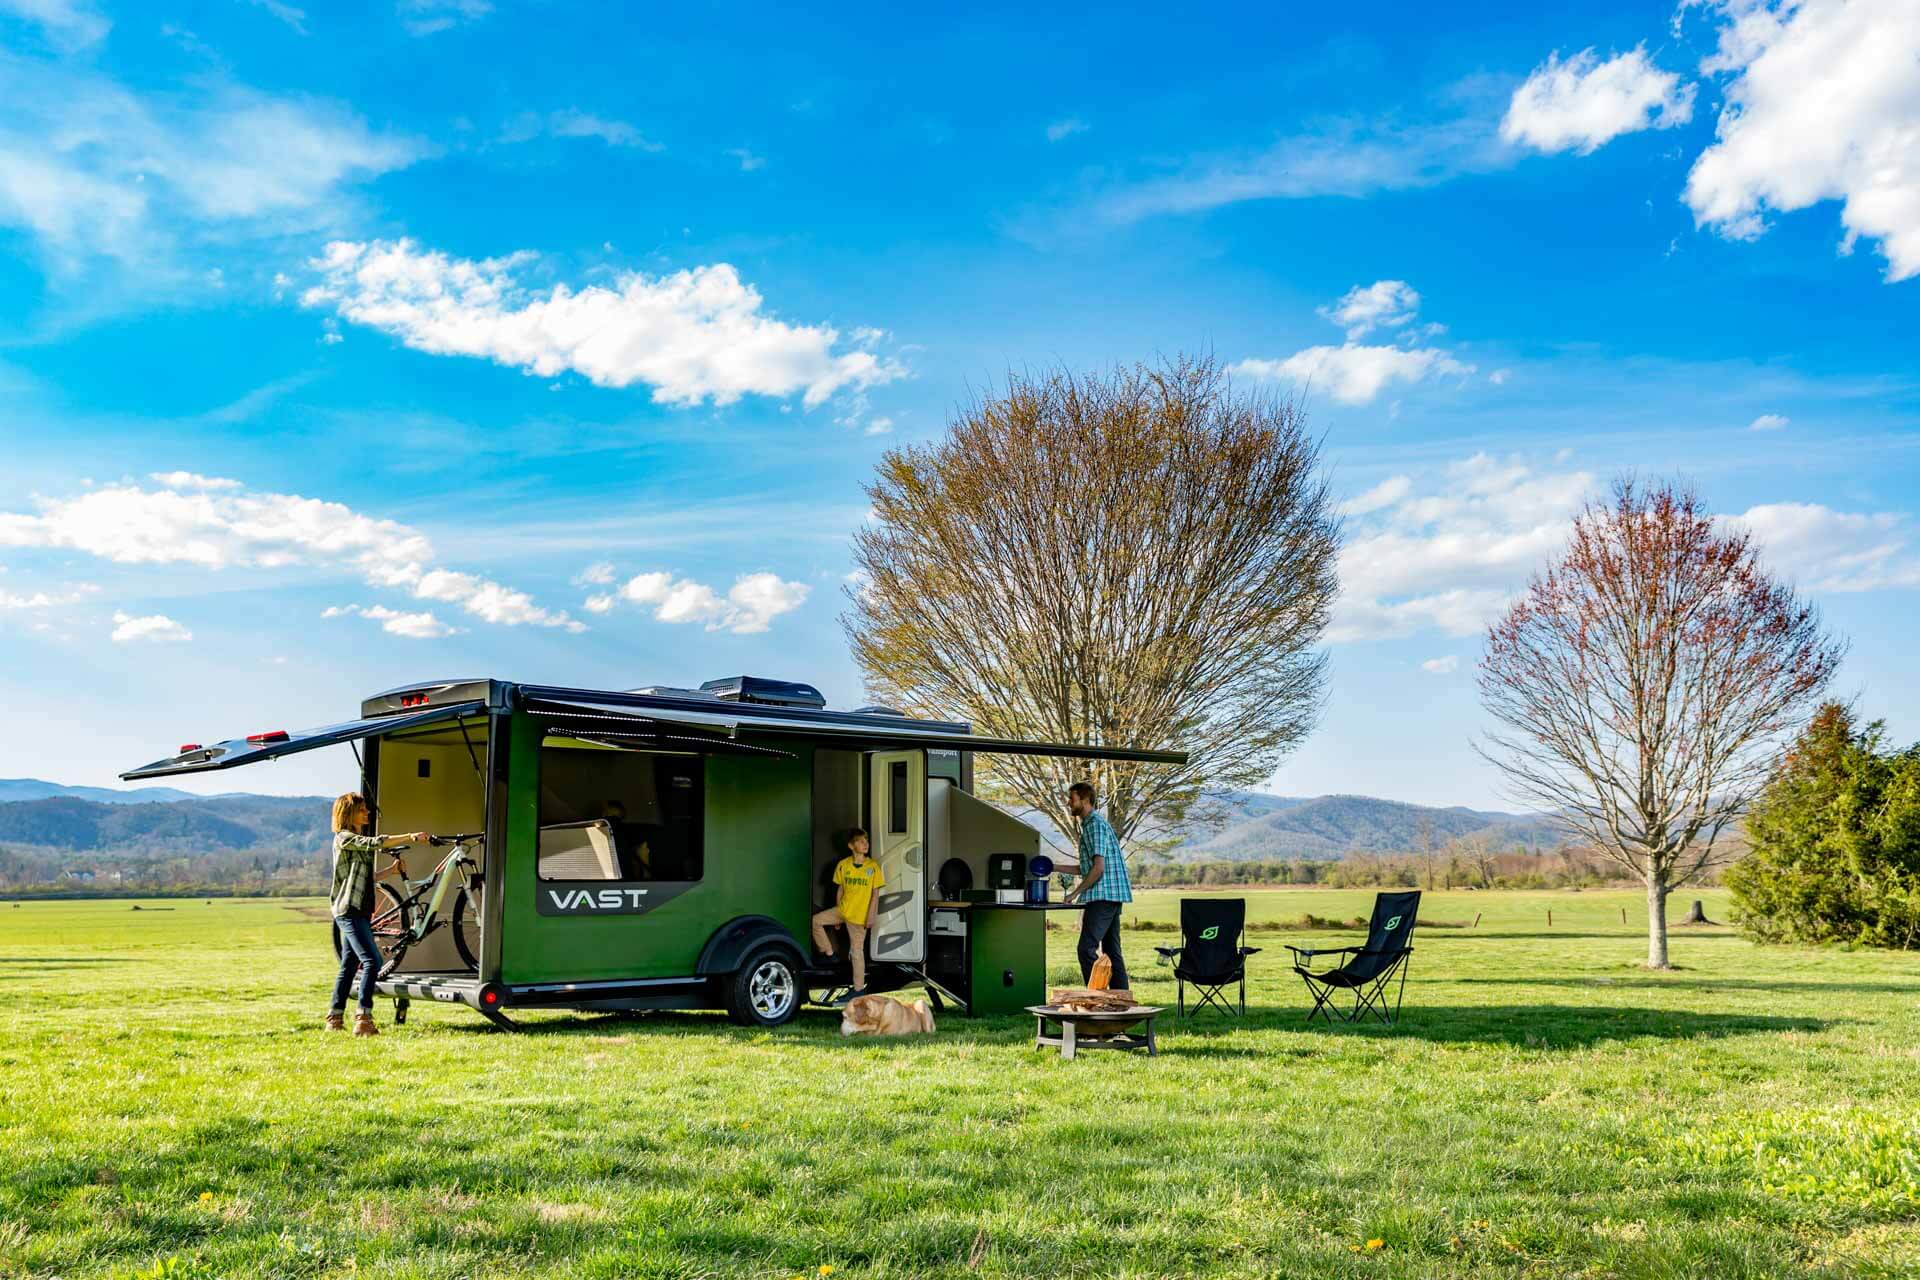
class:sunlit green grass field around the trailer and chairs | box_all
[0,890,1920,1280]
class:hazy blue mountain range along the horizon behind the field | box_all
[0,779,1565,860]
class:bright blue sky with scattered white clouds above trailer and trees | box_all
[0,0,1920,806]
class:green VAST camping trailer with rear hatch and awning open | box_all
[121,677,1187,1027]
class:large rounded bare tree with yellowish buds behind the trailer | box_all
[841,359,1338,846]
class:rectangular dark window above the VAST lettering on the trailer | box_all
[540,745,707,883]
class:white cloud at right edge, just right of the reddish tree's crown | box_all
[1728,503,1920,593]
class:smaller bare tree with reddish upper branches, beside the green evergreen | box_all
[1480,480,1845,969]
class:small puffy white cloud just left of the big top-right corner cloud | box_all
[1500,46,1693,155]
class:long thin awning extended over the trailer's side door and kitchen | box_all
[526,695,1187,764]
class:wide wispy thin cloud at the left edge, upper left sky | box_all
[0,52,419,288]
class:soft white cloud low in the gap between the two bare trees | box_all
[1327,453,1594,643]
